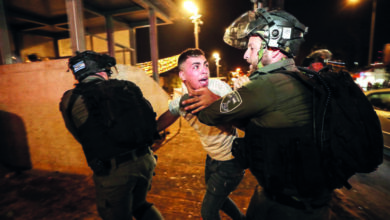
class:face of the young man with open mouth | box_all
[179,56,210,92]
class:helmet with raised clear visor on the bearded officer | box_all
[223,8,308,57]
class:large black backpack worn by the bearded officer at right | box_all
[286,67,383,189]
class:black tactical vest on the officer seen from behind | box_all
[70,80,157,160]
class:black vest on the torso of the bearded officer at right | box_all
[244,122,326,197]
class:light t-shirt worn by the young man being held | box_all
[169,79,237,161]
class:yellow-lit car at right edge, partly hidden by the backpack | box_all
[365,88,390,153]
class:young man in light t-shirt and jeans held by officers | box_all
[157,49,245,220]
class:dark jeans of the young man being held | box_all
[201,156,245,220]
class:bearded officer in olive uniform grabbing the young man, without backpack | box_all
[182,8,332,220]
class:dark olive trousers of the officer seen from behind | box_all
[93,150,163,220]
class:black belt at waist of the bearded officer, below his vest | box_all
[267,195,327,210]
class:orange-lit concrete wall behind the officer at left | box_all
[0,59,169,173]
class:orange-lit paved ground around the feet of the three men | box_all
[0,121,390,220]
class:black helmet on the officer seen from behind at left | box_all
[69,50,116,81]
